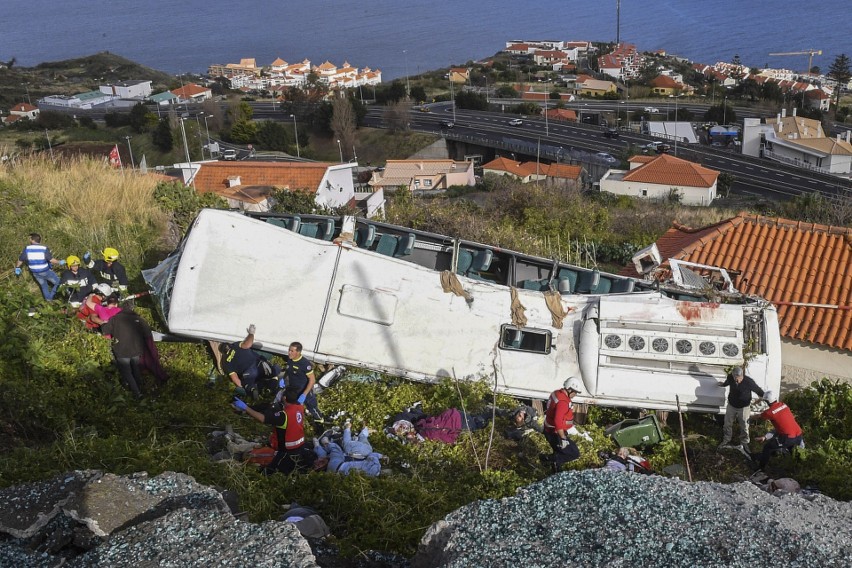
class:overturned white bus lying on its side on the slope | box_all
[144,209,781,412]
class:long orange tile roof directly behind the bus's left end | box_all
[195,162,332,193]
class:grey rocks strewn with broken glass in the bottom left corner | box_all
[0,471,317,568]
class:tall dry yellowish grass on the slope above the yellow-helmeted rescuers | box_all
[0,154,168,267]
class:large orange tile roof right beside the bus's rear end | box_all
[644,213,852,350]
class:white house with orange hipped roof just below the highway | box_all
[600,154,719,205]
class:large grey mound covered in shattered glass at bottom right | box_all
[412,470,852,568]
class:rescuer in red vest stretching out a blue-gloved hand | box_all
[233,387,315,475]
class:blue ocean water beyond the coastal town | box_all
[0,0,852,80]
